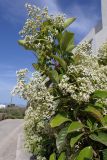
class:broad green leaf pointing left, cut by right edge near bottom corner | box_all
[89,132,107,146]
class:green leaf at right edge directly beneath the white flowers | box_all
[92,90,107,98]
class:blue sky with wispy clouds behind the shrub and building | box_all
[0,0,101,104]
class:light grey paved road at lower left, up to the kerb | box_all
[0,119,23,160]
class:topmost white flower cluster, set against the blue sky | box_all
[20,4,65,54]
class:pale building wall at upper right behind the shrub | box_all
[81,0,107,54]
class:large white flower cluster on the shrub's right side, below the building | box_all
[59,44,107,103]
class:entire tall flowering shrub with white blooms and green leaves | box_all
[13,4,107,160]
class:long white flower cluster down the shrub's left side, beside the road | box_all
[13,69,57,160]
